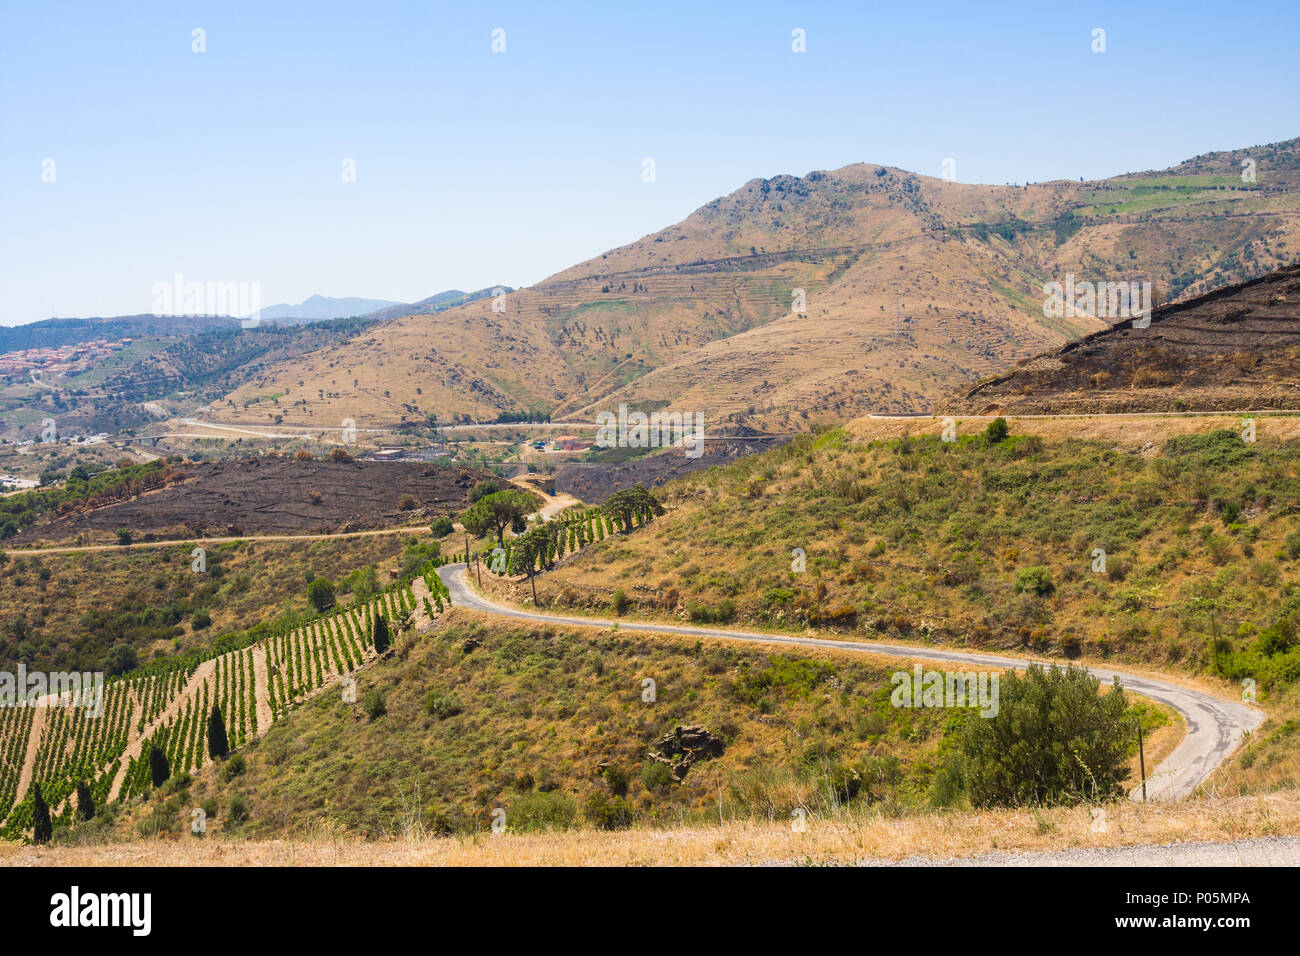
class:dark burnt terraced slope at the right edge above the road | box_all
[940,265,1300,415]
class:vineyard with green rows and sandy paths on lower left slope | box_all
[0,558,451,840]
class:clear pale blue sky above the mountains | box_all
[0,0,1300,325]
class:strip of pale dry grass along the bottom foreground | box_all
[0,791,1300,866]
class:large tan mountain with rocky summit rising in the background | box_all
[217,140,1300,431]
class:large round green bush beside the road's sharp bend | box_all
[956,665,1132,808]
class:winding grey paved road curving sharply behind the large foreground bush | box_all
[438,564,1264,800]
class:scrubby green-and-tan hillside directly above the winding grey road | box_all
[525,419,1300,692]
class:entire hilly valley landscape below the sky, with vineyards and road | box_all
[0,140,1300,862]
